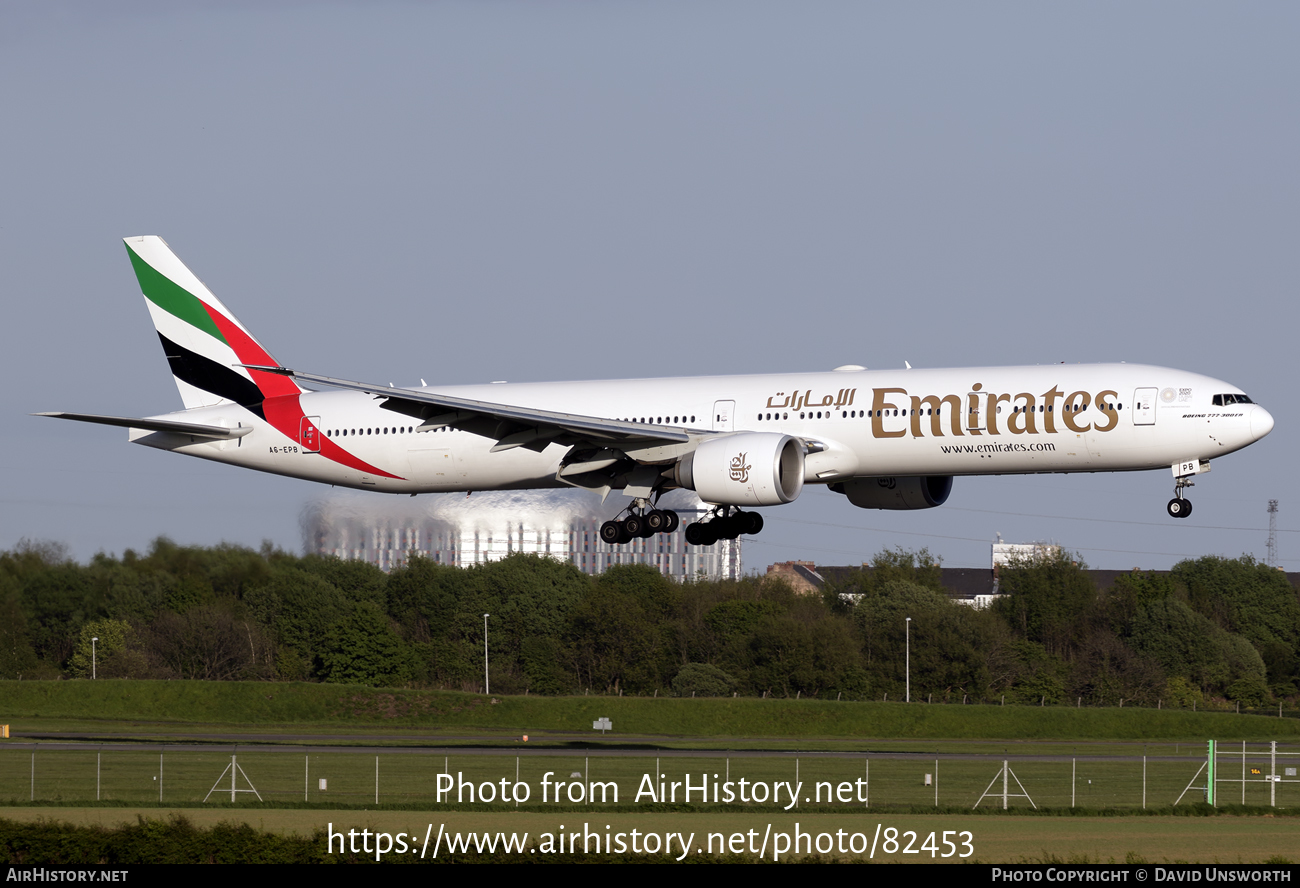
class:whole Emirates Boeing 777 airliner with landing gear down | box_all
[42,237,1273,545]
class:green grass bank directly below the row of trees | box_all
[0,681,1300,742]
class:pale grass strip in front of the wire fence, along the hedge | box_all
[0,807,1297,863]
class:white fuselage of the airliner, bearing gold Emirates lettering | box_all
[131,364,1273,493]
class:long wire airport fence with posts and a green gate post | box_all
[0,742,1300,810]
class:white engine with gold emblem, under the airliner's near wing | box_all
[673,432,803,506]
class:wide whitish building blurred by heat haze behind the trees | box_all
[302,490,742,581]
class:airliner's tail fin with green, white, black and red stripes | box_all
[125,235,302,416]
